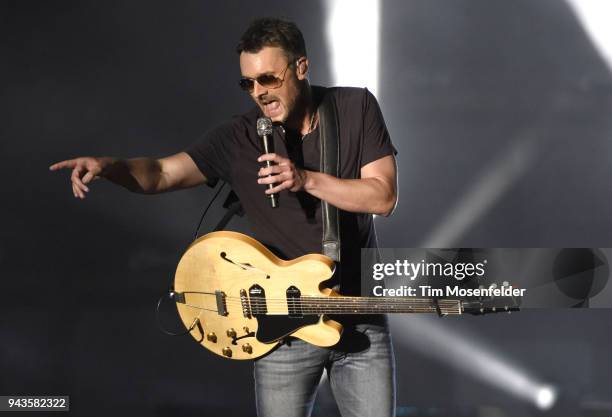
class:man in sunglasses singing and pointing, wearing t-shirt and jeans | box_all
[50,18,397,417]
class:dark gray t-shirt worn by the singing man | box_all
[187,87,396,294]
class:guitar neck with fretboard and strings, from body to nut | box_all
[287,296,462,315]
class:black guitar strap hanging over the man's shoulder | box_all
[318,91,340,262]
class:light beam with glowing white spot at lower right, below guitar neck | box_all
[390,315,557,410]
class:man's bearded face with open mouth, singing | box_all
[240,46,307,123]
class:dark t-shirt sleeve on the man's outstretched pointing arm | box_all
[185,119,235,187]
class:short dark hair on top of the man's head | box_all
[236,17,306,63]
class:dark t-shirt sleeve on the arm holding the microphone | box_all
[361,89,397,167]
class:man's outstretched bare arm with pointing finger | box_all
[49,152,206,198]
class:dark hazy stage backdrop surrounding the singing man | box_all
[0,0,612,416]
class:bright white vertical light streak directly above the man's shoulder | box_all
[323,0,380,96]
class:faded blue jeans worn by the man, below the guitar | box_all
[255,324,395,417]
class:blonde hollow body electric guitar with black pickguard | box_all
[172,231,517,359]
